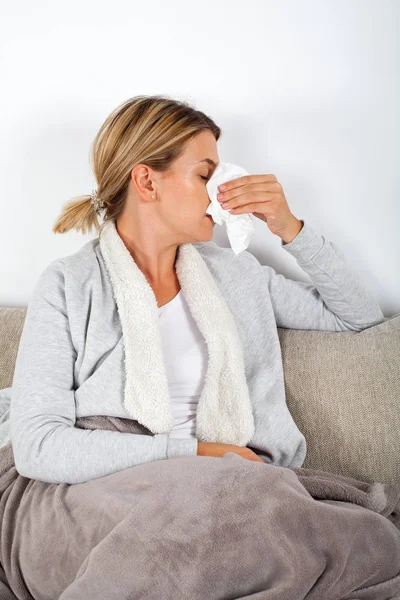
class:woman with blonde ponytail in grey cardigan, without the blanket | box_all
[11,96,384,483]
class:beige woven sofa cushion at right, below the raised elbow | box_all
[278,313,400,483]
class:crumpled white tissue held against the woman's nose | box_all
[206,162,254,254]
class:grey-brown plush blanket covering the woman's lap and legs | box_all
[0,416,400,600]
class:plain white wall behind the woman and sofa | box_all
[0,0,400,316]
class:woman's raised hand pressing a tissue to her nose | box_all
[217,175,303,244]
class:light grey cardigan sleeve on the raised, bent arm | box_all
[243,221,385,331]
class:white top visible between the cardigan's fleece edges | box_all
[158,290,208,438]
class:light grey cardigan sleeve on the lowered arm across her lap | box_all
[10,259,198,484]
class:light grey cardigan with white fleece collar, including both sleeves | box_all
[3,222,384,483]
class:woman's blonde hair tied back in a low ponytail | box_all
[53,95,221,234]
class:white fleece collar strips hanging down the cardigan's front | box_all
[99,221,255,446]
